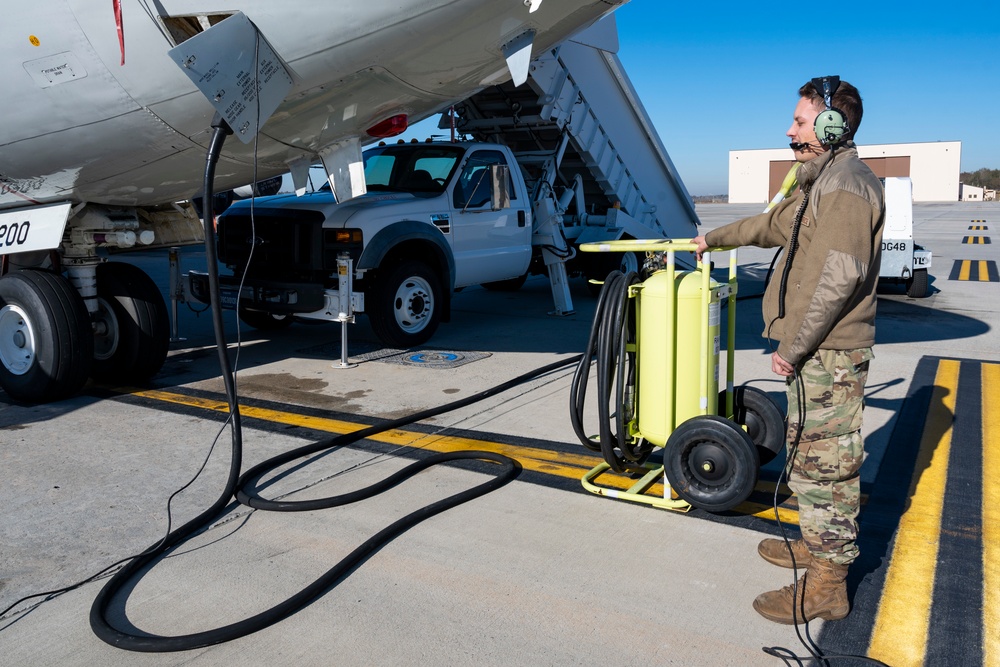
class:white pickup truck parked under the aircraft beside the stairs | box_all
[190,142,650,348]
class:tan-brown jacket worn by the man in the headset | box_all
[705,142,885,364]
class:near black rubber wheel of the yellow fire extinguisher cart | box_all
[663,415,760,512]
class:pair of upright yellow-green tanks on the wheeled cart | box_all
[636,270,719,447]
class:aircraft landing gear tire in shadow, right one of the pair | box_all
[91,262,170,382]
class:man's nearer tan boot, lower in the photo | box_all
[753,558,851,625]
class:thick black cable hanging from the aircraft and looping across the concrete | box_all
[90,119,580,652]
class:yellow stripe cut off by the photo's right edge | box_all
[982,364,1000,667]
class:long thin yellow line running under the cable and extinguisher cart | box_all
[125,387,799,525]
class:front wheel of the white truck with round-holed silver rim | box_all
[368,260,442,348]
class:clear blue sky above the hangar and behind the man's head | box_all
[615,0,1000,195]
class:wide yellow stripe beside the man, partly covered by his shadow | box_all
[868,359,960,667]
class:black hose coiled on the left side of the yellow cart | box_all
[570,271,653,473]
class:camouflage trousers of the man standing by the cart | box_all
[787,348,874,565]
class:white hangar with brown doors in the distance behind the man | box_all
[729,141,962,204]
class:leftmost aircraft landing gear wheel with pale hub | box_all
[0,269,94,403]
